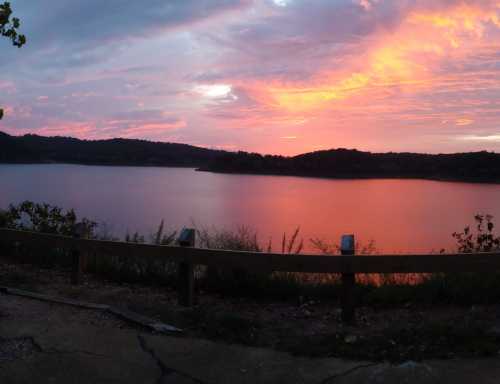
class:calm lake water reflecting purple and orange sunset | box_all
[0,165,500,252]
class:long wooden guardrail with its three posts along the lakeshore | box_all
[0,229,500,322]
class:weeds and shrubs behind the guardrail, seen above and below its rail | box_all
[0,202,500,306]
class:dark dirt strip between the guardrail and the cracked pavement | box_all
[0,261,500,362]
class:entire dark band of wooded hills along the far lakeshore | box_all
[0,132,500,182]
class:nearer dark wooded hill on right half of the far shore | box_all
[204,149,500,182]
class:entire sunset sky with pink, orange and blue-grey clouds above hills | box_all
[0,0,500,155]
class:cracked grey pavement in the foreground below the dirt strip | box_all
[5,292,500,384]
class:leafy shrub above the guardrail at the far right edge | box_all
[453,215,500,253]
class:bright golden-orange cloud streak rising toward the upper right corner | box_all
[259,3,500,113]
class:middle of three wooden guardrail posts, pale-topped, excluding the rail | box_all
[177,228,196,307]
